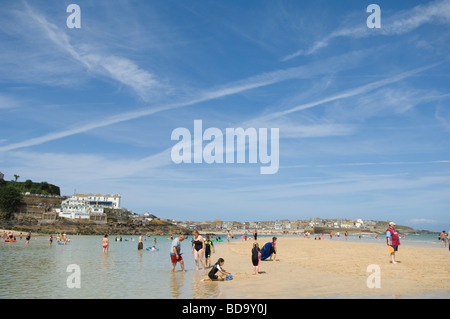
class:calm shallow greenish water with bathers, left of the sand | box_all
[0,236,225,299]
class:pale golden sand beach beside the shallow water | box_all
[210,237,450,299]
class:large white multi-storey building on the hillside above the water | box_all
[59,194,120,219]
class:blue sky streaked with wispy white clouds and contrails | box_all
[0,0,450,231]
